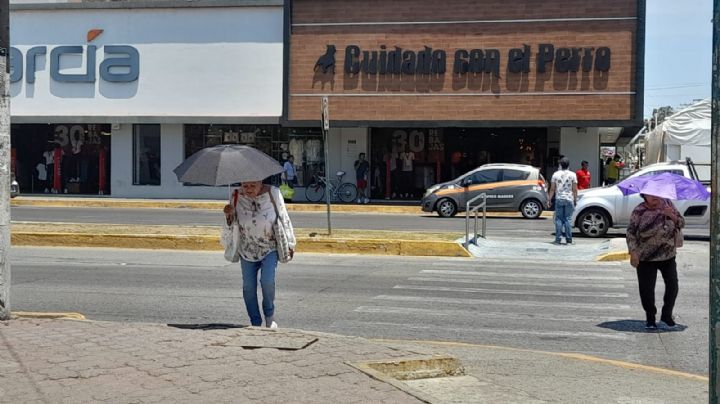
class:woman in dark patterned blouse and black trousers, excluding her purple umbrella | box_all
[626,194,685,329]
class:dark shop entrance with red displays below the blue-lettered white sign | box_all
[10,124,111,195]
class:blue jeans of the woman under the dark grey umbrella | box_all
[240,251,278,327]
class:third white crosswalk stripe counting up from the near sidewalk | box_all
[373,295,630,310]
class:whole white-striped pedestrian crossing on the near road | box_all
[340,258,642,352]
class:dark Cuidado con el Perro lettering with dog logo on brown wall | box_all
[315,44,611,77]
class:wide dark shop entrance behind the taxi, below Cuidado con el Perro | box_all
[370,128,547,200]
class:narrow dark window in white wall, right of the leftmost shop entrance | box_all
[133,125,160,185]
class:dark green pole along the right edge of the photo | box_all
[708,0,720,404]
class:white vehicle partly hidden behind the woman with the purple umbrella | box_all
[572,162,710,237]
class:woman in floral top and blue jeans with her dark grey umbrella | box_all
[173,145,295,328]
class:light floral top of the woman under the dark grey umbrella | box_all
[221,187,295,262]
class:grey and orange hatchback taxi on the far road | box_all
[421,164,547,219]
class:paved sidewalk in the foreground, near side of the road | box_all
[0,318,708,403]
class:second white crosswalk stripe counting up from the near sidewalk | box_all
[353,306,617,324]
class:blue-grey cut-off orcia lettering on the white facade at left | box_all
[10,45,140,84]
